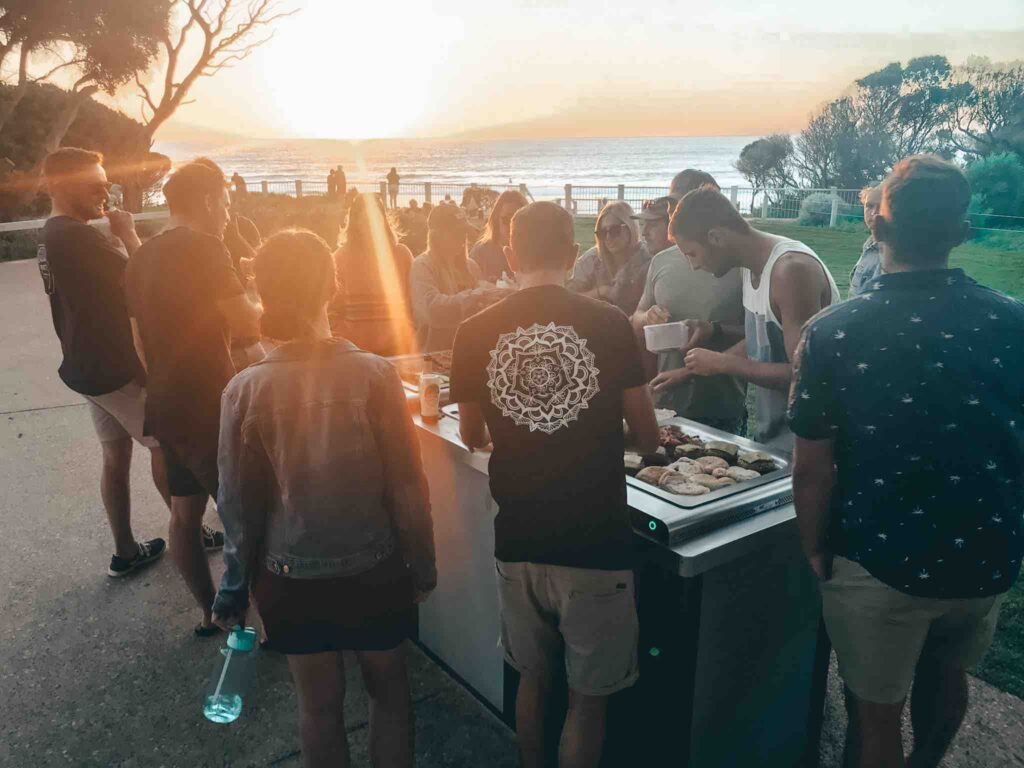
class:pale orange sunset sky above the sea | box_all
[120,0,1024,139]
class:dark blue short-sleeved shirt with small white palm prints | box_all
[790,269,1024,599]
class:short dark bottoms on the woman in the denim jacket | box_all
[252,552,416,655]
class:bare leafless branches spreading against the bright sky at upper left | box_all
[135,0,296,140]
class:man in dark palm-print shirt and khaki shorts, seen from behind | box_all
[790,155,1024,768]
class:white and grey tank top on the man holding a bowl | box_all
[743,240,841,451]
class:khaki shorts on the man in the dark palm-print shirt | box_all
[821,557,1004,703]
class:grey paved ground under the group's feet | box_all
[0,262,1024,768]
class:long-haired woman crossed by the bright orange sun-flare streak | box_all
[330,195,416,357]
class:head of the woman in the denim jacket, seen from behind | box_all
[254,229,338,341]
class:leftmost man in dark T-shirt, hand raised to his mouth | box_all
[38,146,171,578]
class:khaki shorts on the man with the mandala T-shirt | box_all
[495,560,640,696]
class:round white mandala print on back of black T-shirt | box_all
[487,323,600,434]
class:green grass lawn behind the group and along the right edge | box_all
[577,218,1024,698]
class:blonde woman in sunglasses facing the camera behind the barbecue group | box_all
[566,200,650,315]
